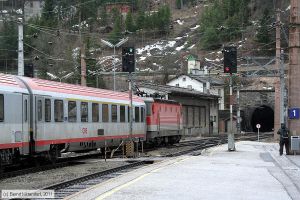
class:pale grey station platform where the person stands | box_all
[68,141,300,200]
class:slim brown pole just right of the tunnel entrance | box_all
[274,9,281,138]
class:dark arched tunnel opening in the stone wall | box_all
[251,106,274,132]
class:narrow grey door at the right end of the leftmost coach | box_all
[21,94,30,154]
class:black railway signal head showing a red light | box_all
[223,47,237,74]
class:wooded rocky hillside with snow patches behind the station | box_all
[0,0,289,87]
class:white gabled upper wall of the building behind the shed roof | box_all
[167,76,204,92]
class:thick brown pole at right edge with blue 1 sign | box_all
[288,0,300,135]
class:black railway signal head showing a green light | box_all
[122,47,135,73]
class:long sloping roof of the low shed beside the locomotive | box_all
[137,82,220,99]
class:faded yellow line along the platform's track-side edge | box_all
[96,157,190,200]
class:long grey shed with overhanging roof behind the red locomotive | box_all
[137,82,220,136]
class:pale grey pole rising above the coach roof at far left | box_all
[18,18,24,76]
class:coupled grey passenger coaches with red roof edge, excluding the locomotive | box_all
[0,74,146,165]
